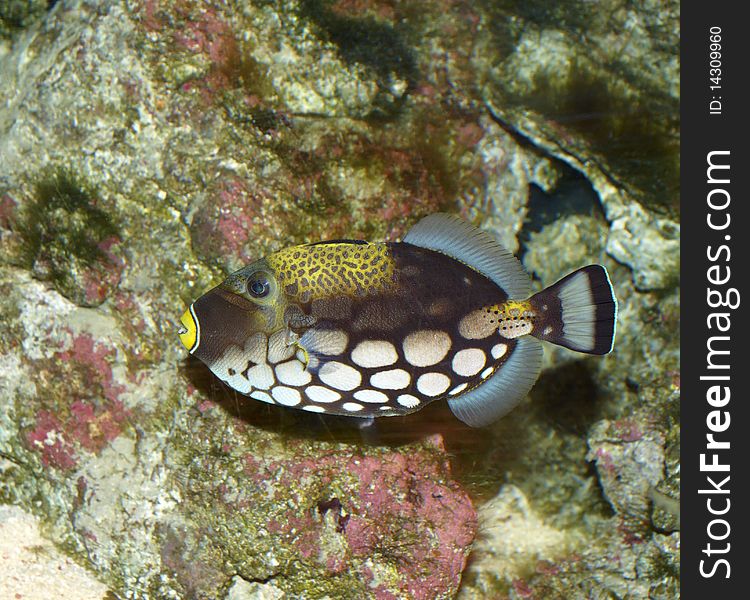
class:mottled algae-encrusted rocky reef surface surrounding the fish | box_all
[0,0,680,599]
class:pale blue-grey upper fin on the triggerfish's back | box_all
[403,213,531,300]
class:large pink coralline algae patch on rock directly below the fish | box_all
[245,439,477,600]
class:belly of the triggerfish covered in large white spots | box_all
[214,327,514,417]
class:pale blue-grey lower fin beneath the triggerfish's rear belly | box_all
[448,336,544,427]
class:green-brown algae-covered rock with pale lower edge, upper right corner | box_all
[476,0,679,291]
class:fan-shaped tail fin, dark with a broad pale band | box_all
[530,265,617,354]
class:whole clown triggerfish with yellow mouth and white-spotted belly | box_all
[178,213,617,427]
